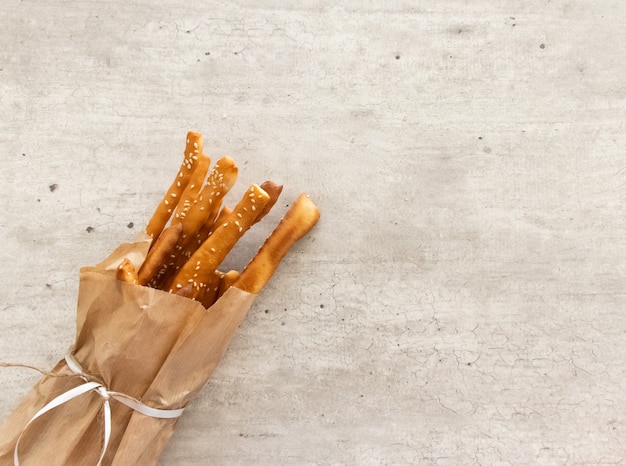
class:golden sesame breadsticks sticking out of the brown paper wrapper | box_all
[120,137,319,307]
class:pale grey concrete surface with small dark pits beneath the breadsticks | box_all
[0,0,626,465]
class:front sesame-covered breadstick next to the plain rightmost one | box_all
[170,184,269,297]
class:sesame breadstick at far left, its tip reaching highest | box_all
[146,131,202,239]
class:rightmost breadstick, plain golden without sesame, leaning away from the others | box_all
[233,194,320,294]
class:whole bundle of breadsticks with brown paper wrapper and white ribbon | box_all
[0,132,319,466]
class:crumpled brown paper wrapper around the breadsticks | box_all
[0,237,255,466]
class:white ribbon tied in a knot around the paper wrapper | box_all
[13,354,185,466]
